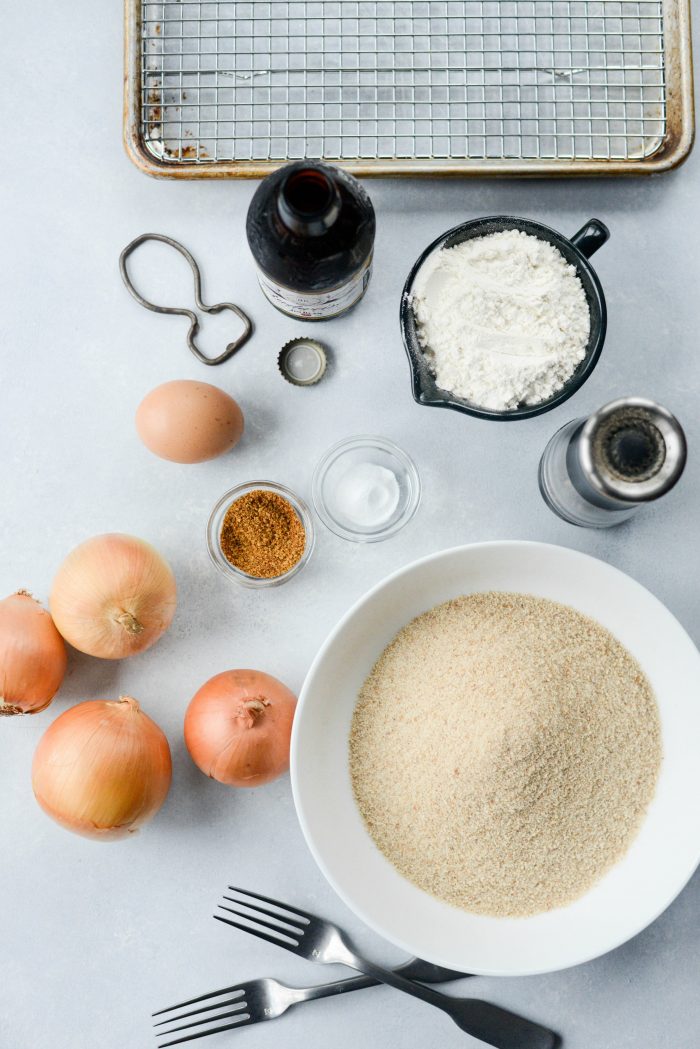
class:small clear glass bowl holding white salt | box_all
[312,435,421,542]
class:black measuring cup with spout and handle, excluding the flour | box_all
[400,215,610,420]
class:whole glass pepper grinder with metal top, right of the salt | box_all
[539,397,686,528]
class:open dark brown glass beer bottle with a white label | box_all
[247,160,375,321]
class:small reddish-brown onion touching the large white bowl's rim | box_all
[185,670,297,787]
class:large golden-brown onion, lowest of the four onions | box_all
[31,695,172,841]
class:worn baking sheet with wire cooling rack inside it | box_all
[126,0,693,176]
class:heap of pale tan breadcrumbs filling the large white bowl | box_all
[349,592,661,918]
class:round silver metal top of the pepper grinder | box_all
[576,397,687,504]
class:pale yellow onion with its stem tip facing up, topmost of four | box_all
[48,533,177,659]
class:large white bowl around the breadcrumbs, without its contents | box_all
[292,542,700,976]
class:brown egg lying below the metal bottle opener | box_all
[136,379,243,463]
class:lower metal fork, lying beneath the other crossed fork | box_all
[153,958,467,1049]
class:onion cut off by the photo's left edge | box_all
[0,591,67,714]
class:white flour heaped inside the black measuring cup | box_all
[411,230,591,411]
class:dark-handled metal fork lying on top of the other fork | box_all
[214,885,559,1049]
